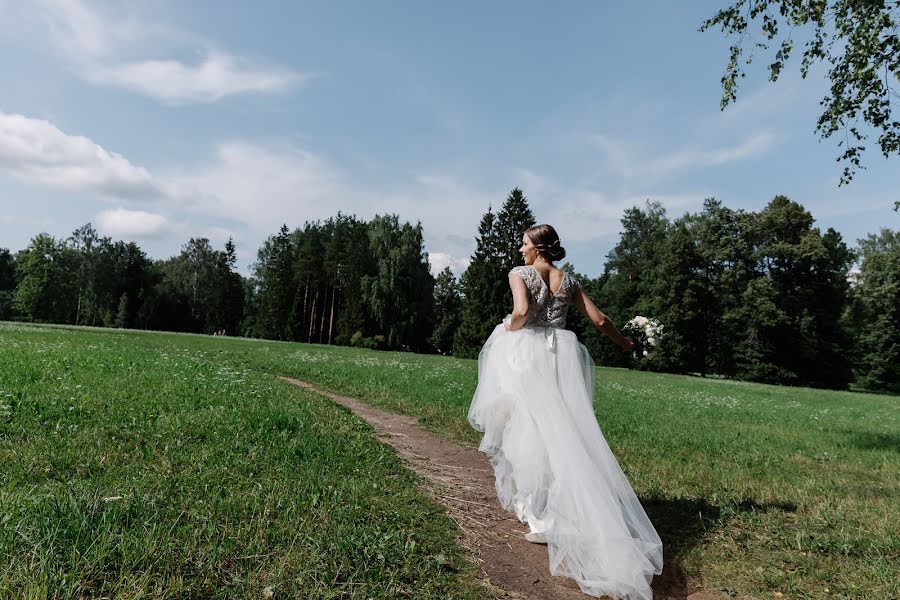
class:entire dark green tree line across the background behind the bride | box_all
[0,188,900,393]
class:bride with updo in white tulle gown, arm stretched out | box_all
[469,225,662,600]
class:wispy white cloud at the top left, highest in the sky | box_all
[31,0,308,104]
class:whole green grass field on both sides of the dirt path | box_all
[0,324,900,599]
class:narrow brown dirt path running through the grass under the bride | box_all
[282,377,723,600]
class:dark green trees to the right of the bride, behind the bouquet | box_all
[568,196,900,392]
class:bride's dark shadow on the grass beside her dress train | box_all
[641,498,797,600]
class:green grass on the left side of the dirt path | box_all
[0,324,490,598]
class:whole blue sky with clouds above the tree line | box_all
[0,0,900,276]
